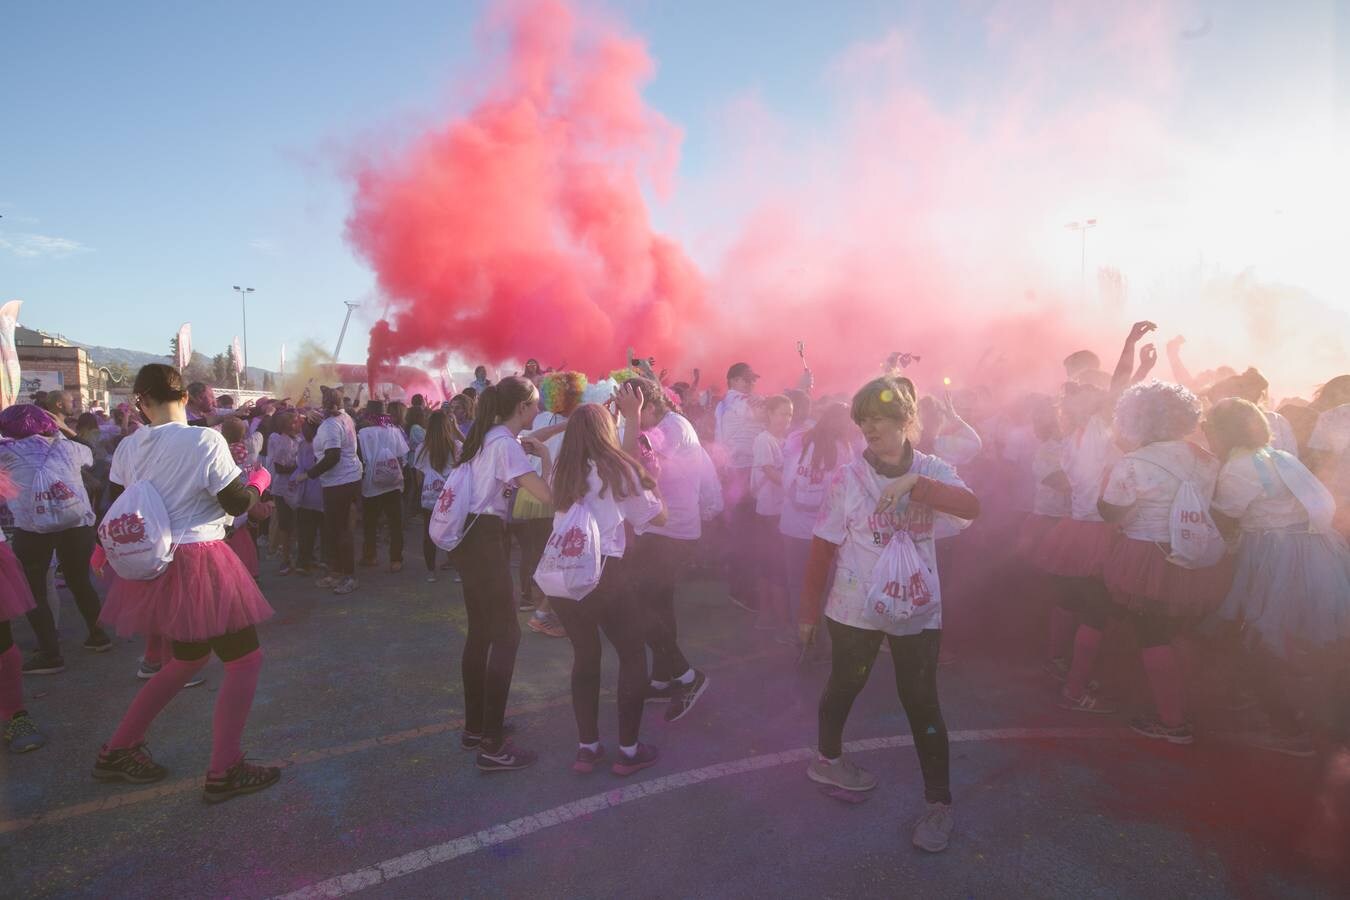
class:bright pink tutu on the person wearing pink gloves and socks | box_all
[99,541,273,641]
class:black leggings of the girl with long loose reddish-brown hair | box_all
[552,559,647,746]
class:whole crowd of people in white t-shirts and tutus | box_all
[0,322,1350,851]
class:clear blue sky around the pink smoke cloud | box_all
[0,0,1346,368]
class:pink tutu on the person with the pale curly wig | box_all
[1103,536,1233,618]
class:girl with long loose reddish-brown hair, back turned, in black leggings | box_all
[549,403,666,776]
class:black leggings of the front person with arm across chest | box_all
[819,617,952,803]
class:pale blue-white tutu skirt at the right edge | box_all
[1214,530,1350,658]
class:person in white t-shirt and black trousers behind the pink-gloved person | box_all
[290,387,363,594]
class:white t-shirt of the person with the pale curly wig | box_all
[1102,441,1219,542]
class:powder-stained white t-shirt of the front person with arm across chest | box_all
[815,451,968,634]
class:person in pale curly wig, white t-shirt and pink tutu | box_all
[1101,382,1233,743]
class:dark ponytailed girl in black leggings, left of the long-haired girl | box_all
[450,375,554,772]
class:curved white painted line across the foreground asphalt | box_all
[279,729,1129,900]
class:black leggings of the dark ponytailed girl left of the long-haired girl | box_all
[450,515,520,748]
